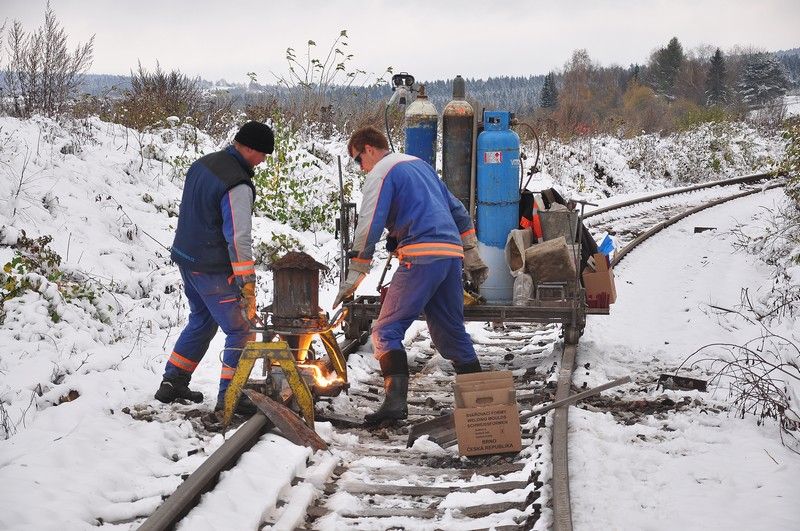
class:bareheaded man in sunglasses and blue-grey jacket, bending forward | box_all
[333,127,489,425]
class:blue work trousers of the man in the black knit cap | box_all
[164,266,255,397]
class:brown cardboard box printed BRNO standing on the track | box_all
[453,371,522,455]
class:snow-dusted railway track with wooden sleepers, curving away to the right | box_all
[140,171,781,531]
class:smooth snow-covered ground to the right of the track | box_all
[569,190,800,530]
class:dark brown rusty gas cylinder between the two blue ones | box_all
[442,76,475,210]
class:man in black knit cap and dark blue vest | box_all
[155,122,275,414]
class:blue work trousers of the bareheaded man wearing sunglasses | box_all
[372,258,477,365]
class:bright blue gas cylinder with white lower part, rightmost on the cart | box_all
[476,111,520,304]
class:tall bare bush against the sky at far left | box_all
[4,1,94,116]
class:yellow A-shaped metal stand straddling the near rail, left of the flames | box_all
[222,341,316,430]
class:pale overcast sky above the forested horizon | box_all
[0,0,800,83]
